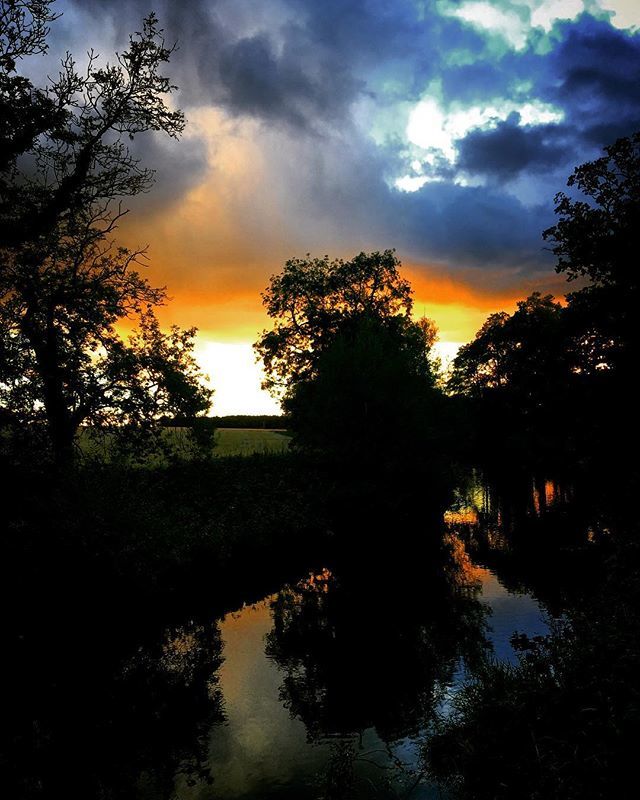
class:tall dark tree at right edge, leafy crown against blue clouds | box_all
[544,132,640,468]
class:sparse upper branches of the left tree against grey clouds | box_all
[0,0,185,248]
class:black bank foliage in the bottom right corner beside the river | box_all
[427,547,640,800]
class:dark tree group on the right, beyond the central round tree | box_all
[449,133,640,476]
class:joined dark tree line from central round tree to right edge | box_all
[255,133,640,482]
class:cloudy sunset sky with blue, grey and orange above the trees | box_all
[50,0,640,414]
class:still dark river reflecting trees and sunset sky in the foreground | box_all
[8,478,557,800]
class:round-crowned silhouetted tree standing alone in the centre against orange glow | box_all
[255,250,437,458]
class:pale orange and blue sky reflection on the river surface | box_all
[177,544,547,800]
